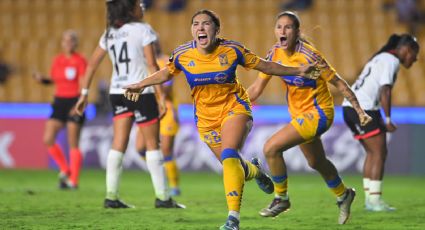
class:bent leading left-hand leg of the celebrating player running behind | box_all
[260,124,305,217]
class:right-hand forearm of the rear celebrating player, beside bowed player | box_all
[329,74,372,126]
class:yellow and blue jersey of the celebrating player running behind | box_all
[260,41,336,118]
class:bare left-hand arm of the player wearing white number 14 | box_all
[75,46,106,115]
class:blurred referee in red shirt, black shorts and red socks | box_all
[33,30,87,189]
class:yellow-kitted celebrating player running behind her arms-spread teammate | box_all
[248,11,371,224]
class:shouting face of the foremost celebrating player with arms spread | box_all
[192,14,218,50]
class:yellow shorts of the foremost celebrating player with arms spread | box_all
[198,105,252,148]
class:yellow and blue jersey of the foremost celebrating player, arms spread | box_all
[168,38,260,129]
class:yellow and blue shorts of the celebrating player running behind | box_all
[291,108,334,142]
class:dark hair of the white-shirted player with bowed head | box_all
[371,34,419,59]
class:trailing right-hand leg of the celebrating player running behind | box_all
[300,137,356,224]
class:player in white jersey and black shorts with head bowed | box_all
[342,34,419,212]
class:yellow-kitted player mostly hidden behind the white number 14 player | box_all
[136,40,181,196]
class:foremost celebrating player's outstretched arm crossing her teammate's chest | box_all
[254,59,320,79]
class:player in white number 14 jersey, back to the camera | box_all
[76,0,184,208]
